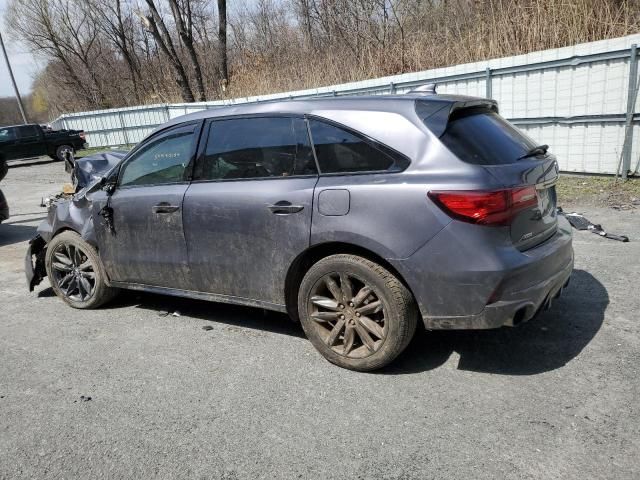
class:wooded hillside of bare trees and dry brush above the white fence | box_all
[6,0,640,114]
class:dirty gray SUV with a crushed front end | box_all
[26,94,573,371]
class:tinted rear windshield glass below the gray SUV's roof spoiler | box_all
[440,108,536,165]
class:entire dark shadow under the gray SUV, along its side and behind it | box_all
[38,270,609,375]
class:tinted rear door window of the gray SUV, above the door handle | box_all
[196,117,317,180]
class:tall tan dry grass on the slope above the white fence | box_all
[227,0,640,96]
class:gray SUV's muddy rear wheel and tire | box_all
[298,254,418,372]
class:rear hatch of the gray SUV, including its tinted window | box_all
[440,106,558,250]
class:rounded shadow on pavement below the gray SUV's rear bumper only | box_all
[388,270,609,375]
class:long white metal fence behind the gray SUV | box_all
[52,35,640,173]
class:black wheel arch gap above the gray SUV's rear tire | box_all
[284,242,415,321]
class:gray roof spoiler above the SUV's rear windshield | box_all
[416,95,498,137]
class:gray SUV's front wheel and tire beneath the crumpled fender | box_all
[45,231,118,309]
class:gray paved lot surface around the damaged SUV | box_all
[0,162,640,479]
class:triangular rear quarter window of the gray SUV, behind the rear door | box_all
[309,119,409,173]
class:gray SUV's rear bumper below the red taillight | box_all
[392,217,573,330]
